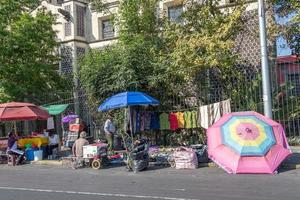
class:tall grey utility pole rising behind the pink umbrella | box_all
[258,0,272,119]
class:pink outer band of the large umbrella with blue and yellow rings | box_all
[206,112,292,174]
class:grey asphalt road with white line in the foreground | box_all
[0,165,300,200]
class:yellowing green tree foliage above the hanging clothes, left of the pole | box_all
[164,0,245,79]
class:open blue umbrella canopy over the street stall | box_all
[98,92,159,111]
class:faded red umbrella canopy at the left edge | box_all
[0,102,50,121]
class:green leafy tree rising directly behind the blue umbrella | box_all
[80,0,180,105]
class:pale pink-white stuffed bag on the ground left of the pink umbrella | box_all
[173,147,198,169]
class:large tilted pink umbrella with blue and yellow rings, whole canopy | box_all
[207,112,292,174]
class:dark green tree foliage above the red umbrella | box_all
[0,0,67,102]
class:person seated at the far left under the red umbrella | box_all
[6,132,25,165]
